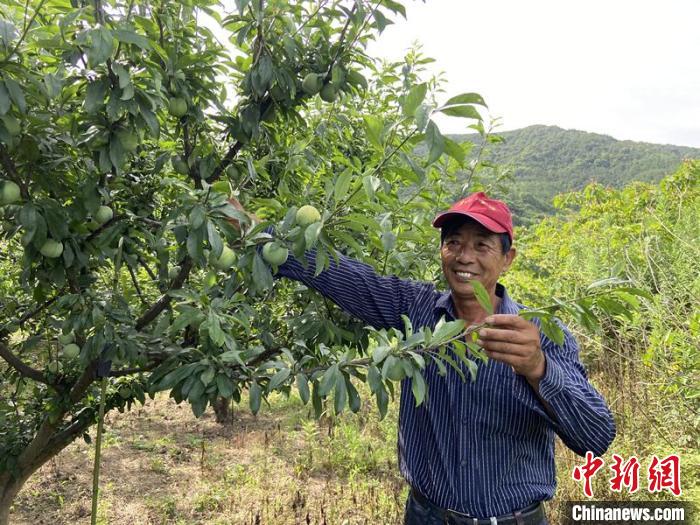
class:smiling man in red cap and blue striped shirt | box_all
[228,192,615,525]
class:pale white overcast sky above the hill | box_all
[368,0,700,147]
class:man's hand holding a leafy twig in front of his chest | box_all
[477,314,546,382]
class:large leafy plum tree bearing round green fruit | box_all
[0,0,536,525]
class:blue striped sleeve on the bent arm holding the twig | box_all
[518,328,615,456]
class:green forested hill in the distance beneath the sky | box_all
[451,126,700,224]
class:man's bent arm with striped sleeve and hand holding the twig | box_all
[479,315,615,455]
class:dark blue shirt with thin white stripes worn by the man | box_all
[278,251,615,517]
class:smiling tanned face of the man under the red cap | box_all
[440,221,515,298]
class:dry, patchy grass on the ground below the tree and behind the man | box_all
[12,372,700,525]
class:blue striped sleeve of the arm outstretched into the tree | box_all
[276,250,435,330]
